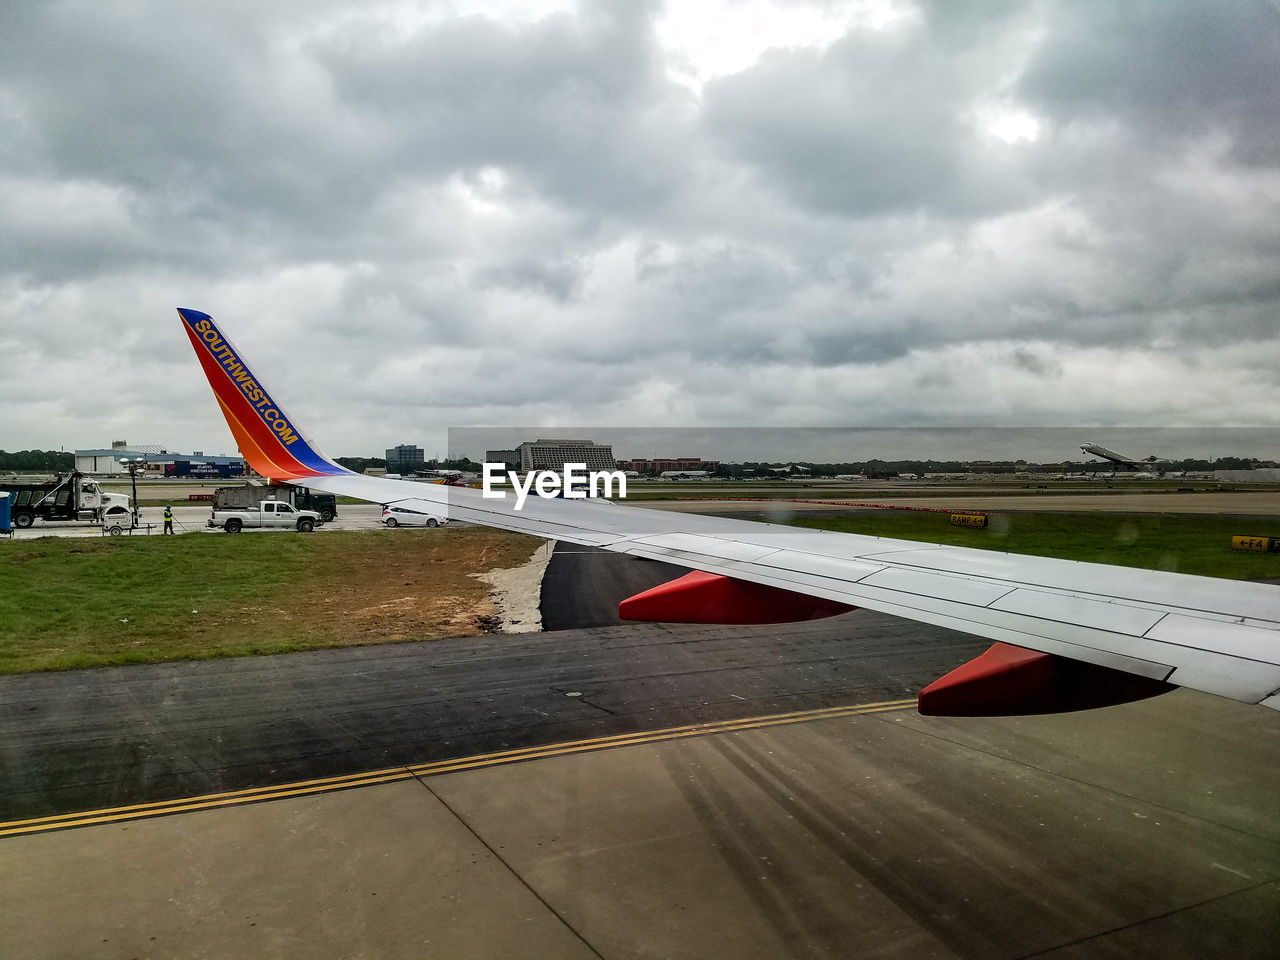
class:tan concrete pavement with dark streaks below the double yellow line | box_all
[0,691,1280,960]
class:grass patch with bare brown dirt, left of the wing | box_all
[0,527,541,673]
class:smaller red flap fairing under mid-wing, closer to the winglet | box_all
[618,570,854,623]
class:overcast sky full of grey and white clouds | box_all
[0,0,1280,456]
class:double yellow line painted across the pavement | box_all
[0,699,915,837]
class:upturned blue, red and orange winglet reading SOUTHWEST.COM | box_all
[178,307,349,481]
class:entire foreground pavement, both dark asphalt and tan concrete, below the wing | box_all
[0,537,1280,960]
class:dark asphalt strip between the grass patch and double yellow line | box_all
[0,611,987,820]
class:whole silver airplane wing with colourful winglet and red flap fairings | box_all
[178,308,1280,716]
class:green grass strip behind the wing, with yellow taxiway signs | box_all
[791,511,1280,580]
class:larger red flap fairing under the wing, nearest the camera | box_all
[919,643,1174,717]
